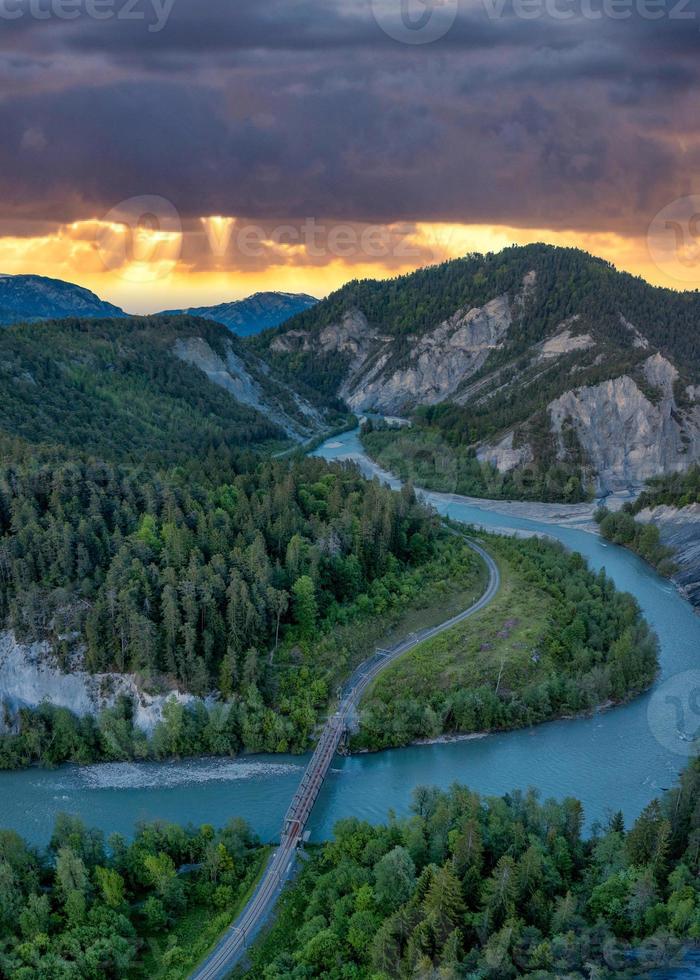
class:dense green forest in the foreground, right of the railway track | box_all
[247,761,700,980]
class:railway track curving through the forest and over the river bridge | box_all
[191,529,501,980]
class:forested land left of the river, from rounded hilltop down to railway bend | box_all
[0,316,446,764]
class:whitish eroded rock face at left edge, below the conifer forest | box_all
[0,630,194,732]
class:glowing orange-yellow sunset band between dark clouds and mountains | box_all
[0,216,688,313]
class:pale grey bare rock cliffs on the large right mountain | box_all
[272,288,700,495]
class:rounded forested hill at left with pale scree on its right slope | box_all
[0,316,330,466]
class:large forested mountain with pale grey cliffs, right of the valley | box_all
[260,245,700,500]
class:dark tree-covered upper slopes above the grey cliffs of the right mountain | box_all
[251,245,700,393]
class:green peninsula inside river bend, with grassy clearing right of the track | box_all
[354,536,658,749]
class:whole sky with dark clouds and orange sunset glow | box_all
[0,0,700,312]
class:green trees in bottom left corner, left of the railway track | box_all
[0,815,267,980]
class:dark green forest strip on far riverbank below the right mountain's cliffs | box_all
[361,424,592,503]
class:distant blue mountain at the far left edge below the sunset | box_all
[0,275,126,326]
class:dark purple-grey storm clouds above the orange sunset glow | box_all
[0,0,700,233]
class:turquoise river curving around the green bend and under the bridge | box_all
[0,432,700,856]
